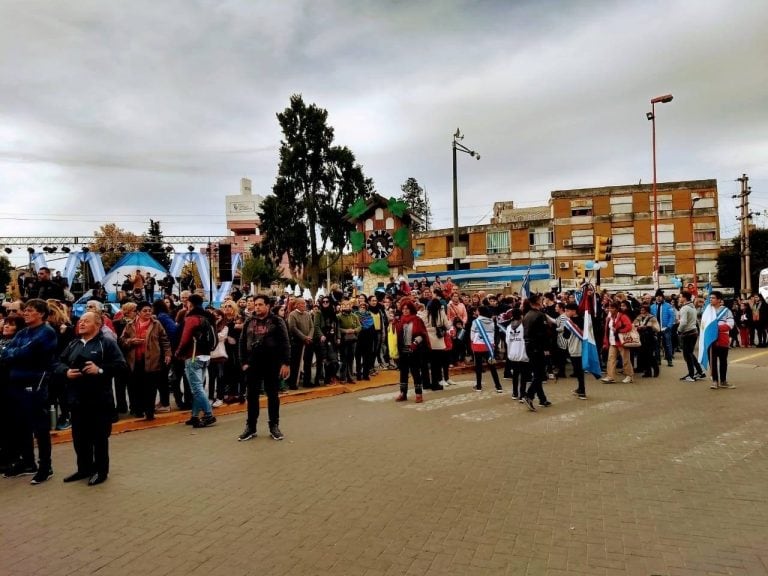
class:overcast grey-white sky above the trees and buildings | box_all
[0,0,768,266]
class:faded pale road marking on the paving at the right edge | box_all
[672,420,768,472]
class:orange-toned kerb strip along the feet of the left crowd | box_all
[51,365,473,444]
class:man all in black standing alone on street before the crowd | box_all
[237,294,291,442]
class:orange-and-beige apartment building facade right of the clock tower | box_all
[414,180,720,287]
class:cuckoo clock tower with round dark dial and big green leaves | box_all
[348,194,413,294]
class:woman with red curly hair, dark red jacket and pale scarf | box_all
[395,298,429,403]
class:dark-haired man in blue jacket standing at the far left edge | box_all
[0,298,57,485]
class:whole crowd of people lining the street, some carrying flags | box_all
[0,269,744,485]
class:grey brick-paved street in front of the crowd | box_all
[0,349,768,576]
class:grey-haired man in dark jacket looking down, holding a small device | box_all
[56,312,127,486]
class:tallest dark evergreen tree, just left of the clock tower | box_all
[259,94,373,286]
